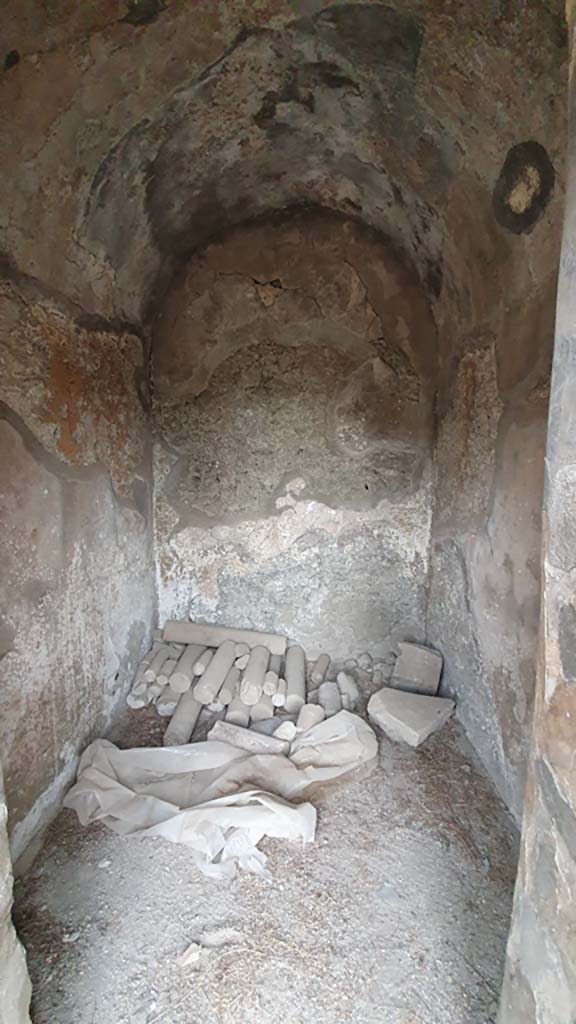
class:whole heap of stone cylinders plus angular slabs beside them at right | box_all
[126,621,454,750]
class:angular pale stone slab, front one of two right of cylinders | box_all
[368,686,455,746]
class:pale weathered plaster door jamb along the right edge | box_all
[498,49,576,1024]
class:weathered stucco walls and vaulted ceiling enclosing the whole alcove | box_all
[0,14,576,1024]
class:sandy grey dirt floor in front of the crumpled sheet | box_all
[15,713,518,1024]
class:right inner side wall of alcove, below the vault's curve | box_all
[427,331,553,821]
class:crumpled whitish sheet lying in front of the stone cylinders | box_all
[65,711,378,878]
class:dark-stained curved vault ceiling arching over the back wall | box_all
[78,3,558,331]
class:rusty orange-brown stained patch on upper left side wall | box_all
[0,284,147,496]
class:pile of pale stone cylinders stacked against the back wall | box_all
[127,620,360,746]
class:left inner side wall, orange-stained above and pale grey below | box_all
[0,278,155,856]
